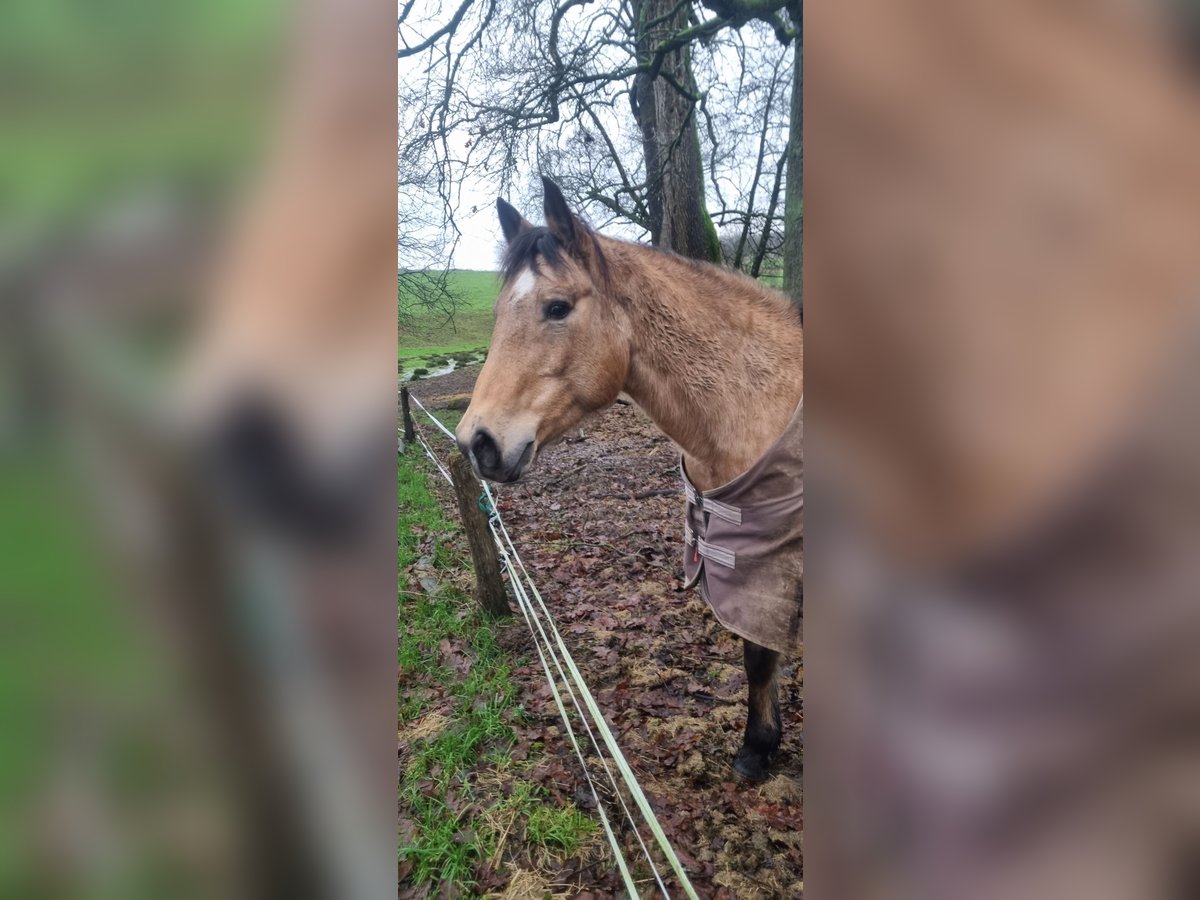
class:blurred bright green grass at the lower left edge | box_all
[0,440,179,896]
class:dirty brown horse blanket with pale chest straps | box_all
[679,401,804,653]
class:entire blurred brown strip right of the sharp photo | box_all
[804,0,1200,900]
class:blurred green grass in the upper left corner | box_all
[0,0,276,234]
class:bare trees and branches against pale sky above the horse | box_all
[400,0,799,282]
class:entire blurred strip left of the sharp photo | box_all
[0,0,396,898]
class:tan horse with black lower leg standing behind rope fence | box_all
[456,178,804,781]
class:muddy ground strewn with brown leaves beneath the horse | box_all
[410,367,803,900]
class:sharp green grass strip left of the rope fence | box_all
[397,441,596,890]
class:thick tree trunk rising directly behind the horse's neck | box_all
[634,0,721,263]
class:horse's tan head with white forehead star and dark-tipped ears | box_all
[457,179,630,482]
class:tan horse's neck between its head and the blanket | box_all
[614,247,803,490]
